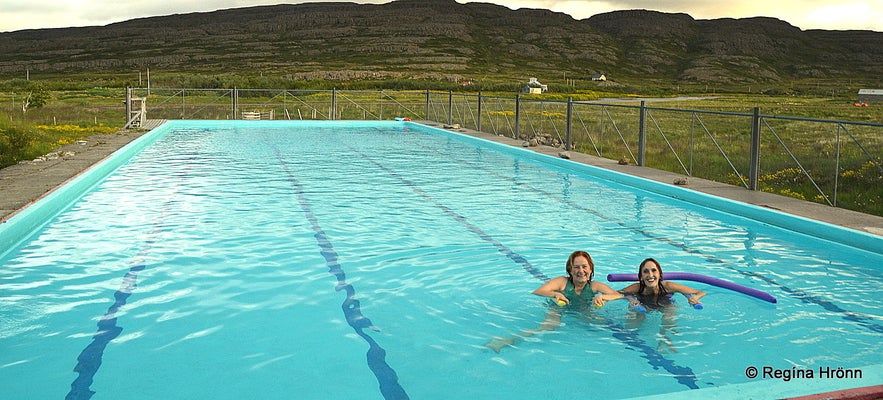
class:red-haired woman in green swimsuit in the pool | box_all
[485,251,623,353]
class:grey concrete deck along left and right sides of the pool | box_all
[0,120,883,236]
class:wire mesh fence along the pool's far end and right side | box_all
[103,88,883,215]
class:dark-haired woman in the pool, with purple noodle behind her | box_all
[619,258,705,352]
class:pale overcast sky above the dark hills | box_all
[0,0,883,32]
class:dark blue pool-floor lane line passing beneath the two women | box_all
[350,148,699,389]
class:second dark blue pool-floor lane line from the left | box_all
[275,149,409,400]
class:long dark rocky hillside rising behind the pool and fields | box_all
[0,0,883,83]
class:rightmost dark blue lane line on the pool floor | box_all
[418,134,883,333]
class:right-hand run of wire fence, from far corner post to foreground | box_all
[426,93,883,215]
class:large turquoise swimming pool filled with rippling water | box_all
[0,121,883,399]
